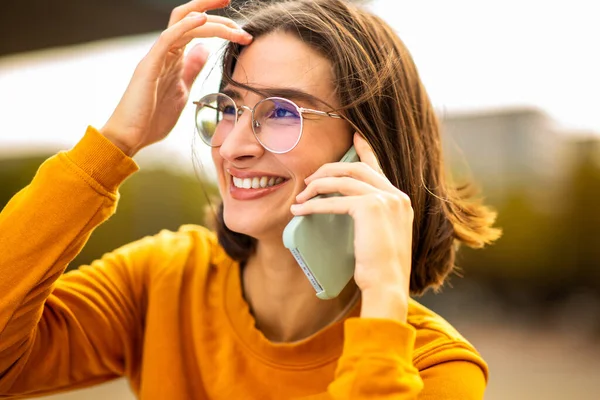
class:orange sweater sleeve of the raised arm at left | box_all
[0,127,141,398]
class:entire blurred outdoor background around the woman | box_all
[0,0,600,400]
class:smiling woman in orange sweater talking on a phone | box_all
[0,0,499,399]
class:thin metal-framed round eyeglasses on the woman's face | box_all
[194,93,342,154]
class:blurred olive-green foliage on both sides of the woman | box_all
[0,145,600,300]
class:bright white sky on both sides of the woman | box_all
[0,0,600,164]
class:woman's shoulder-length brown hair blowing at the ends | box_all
[216,0,501,294]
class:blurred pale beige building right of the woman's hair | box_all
[441,108,567,208]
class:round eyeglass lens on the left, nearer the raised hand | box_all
[196,93,236,147]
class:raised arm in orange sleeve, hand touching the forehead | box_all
[0,0,252,398]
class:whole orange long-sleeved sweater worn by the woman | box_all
[0,128,487,400]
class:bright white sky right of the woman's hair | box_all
[374,0,600,134]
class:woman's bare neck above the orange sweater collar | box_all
[242,239,358,342]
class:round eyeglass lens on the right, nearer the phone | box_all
[252,97,302,153]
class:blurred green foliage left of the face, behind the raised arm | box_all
[0,153,218,268]
